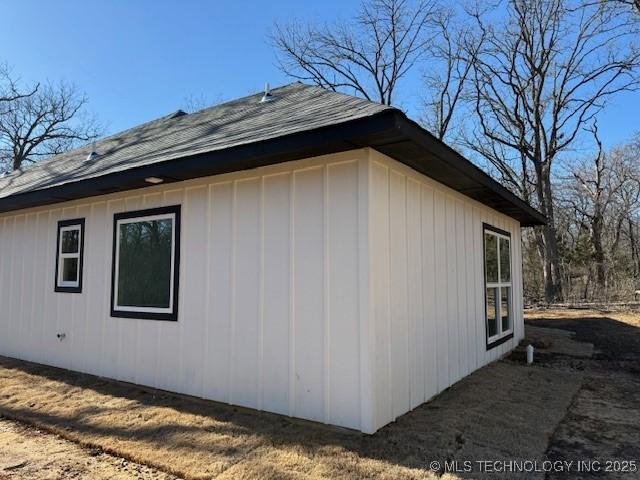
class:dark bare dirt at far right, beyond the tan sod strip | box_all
[527,310,640,479]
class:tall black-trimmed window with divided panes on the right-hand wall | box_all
[484,224,513,349]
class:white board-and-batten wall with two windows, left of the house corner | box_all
[0,150,367,429]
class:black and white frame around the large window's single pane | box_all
[111,205,181,322]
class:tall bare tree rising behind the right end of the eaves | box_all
[466,0,640,301]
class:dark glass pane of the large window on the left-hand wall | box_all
[118,219,173,308]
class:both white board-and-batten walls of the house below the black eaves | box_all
[0,87,539,433]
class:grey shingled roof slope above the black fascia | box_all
[0,83,390,199]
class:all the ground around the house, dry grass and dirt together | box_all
[0,311,640,480]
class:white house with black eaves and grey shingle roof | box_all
[0,83,544,433]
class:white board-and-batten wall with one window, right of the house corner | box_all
[370,150,524,429]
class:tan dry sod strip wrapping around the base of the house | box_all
[0,350,582,479]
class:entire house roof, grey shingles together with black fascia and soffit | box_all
[0,83,545,226]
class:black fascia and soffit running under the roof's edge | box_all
[0,109,545,226]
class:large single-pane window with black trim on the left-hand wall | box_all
[111,206,180,321]
